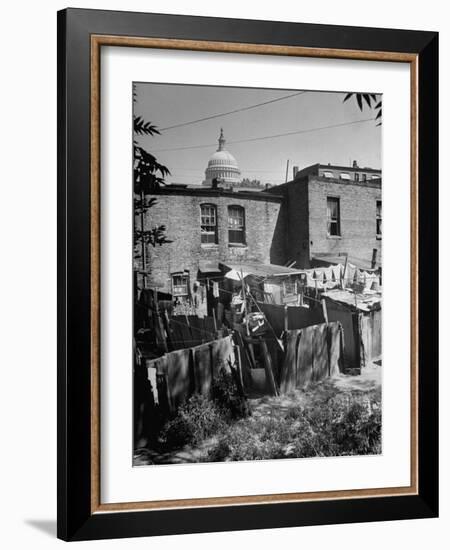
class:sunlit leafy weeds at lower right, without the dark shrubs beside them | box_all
[207,395,381,462]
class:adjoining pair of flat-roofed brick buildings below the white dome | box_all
[136,162,382,306]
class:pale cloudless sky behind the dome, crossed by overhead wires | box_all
[133,83,382,185]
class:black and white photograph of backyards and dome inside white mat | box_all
[130,82,383,467]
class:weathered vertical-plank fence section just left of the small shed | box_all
[280,322,344,393]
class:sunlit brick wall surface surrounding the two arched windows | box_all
[141,191,281,292]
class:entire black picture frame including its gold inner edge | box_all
[58,9,438,540]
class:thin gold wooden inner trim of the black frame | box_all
[90,35,419,514]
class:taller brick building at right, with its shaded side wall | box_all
[268,162,382,268]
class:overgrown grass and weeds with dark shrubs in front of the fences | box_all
[154,373,381,462]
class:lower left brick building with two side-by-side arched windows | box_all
[141,185,283,298]
